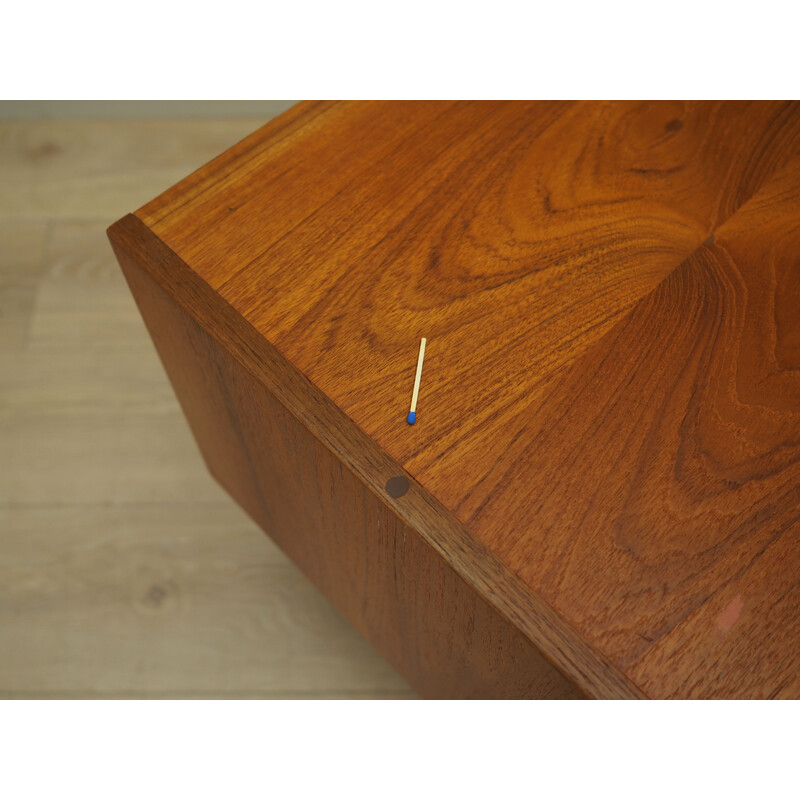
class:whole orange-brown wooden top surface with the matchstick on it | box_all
[137,102,800,697]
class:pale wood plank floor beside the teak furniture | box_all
[0,119,414,698]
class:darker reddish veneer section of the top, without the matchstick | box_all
[470,159,800,696]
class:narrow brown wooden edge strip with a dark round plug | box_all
[108,214,647,699]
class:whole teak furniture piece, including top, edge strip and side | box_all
[109,102,800,697]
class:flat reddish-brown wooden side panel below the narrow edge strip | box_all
[116,230,580,698]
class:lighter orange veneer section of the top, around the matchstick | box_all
[140,103,800,520]
